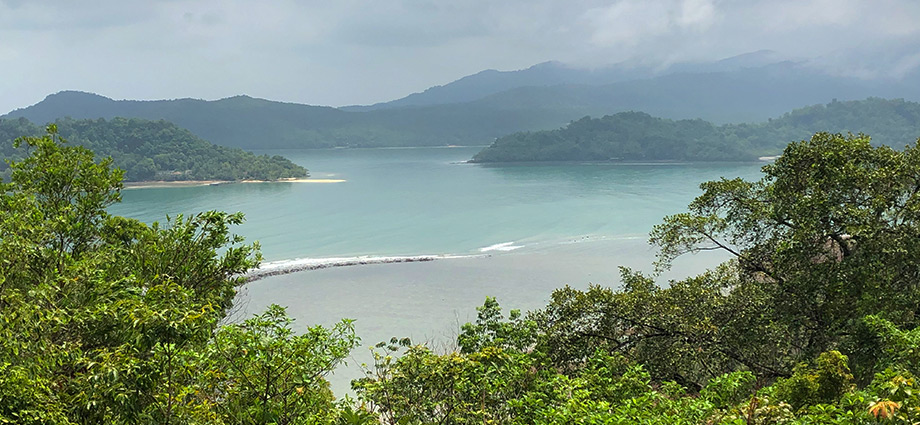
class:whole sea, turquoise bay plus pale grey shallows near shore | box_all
[110,147,764,394]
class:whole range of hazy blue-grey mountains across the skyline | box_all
[3,51,920,148]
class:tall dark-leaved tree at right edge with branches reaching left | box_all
[651,133,920,376]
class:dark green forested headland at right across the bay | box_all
[473,98,920,162]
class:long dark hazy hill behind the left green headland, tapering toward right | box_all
[5,91,568,149]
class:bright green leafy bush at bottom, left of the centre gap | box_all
[197,305,358,424]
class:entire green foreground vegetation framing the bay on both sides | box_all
[0,126,920,424]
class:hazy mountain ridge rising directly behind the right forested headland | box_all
[475,62,920,124]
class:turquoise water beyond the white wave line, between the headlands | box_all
[111,148,760,261]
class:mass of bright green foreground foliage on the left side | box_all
[0,126,357,424]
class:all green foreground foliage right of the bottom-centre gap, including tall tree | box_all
[354,133,920,424]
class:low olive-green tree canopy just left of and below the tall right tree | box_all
[531,267,791,390]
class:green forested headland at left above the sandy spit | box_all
[0,118,307,181]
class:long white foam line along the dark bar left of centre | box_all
[246,255,475,282]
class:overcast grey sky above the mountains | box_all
[0,0,920,114]
